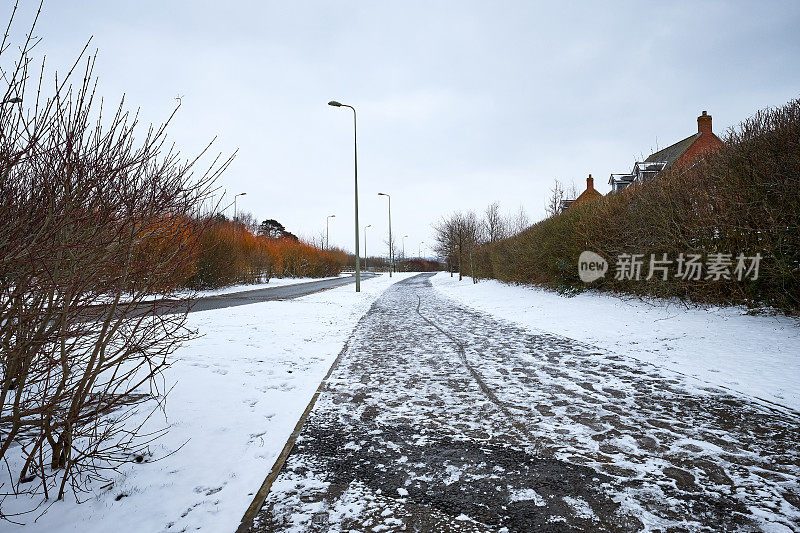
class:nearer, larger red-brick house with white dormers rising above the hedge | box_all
[608,111,724,192]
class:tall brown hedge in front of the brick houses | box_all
[477,100,800,313]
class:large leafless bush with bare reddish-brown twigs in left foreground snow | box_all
[0,3,230,518]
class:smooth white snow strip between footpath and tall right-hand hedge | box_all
[431,272,800,413]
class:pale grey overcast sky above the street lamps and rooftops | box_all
[6,0,800,255]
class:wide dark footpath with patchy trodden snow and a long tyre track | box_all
[254,276,800,531]
